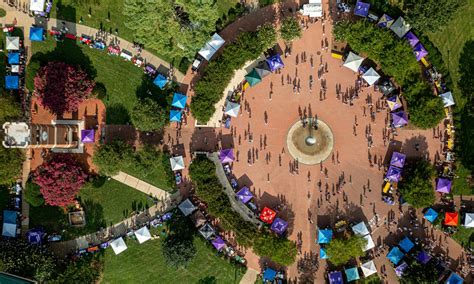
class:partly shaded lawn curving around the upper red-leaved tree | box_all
[27,37,168,124]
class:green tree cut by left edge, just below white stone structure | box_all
[0,146,25,185]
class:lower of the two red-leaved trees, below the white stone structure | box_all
[34,154,87,206]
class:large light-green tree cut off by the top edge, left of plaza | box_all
[123,0,218,59]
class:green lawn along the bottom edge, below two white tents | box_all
[102,233,244,284]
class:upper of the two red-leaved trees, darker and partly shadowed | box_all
[35,61,95,115]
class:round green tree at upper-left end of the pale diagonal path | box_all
[92,139,133,176]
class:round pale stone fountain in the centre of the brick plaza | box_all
[286,120,334,165]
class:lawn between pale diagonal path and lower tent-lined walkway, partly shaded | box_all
[30,180,153,239]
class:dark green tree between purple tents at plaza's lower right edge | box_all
[398,160,435,208]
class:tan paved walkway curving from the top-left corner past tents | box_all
[0,2,184,83]
